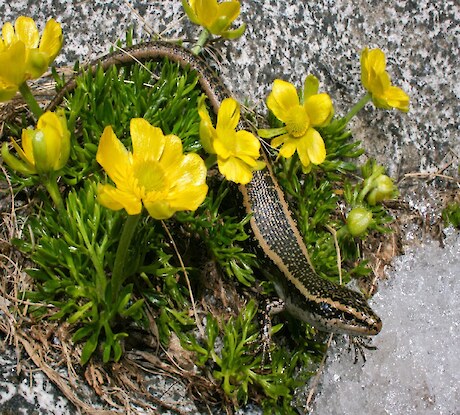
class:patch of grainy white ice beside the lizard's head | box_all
[312,230,460,415]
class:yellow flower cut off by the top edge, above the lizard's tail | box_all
[182,0,246,39]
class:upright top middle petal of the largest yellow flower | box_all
[130,118,165,160]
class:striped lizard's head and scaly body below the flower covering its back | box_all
[246,169,381,334]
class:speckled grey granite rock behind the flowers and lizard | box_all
[0,0,460,413]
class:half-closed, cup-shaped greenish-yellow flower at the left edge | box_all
[2,110,70,175]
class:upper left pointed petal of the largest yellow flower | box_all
[96,126,132,186]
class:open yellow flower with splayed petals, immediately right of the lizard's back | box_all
[259,75,334,169]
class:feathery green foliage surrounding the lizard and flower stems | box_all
[1,31,398,414]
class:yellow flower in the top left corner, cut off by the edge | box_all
[0,16,63,101]
